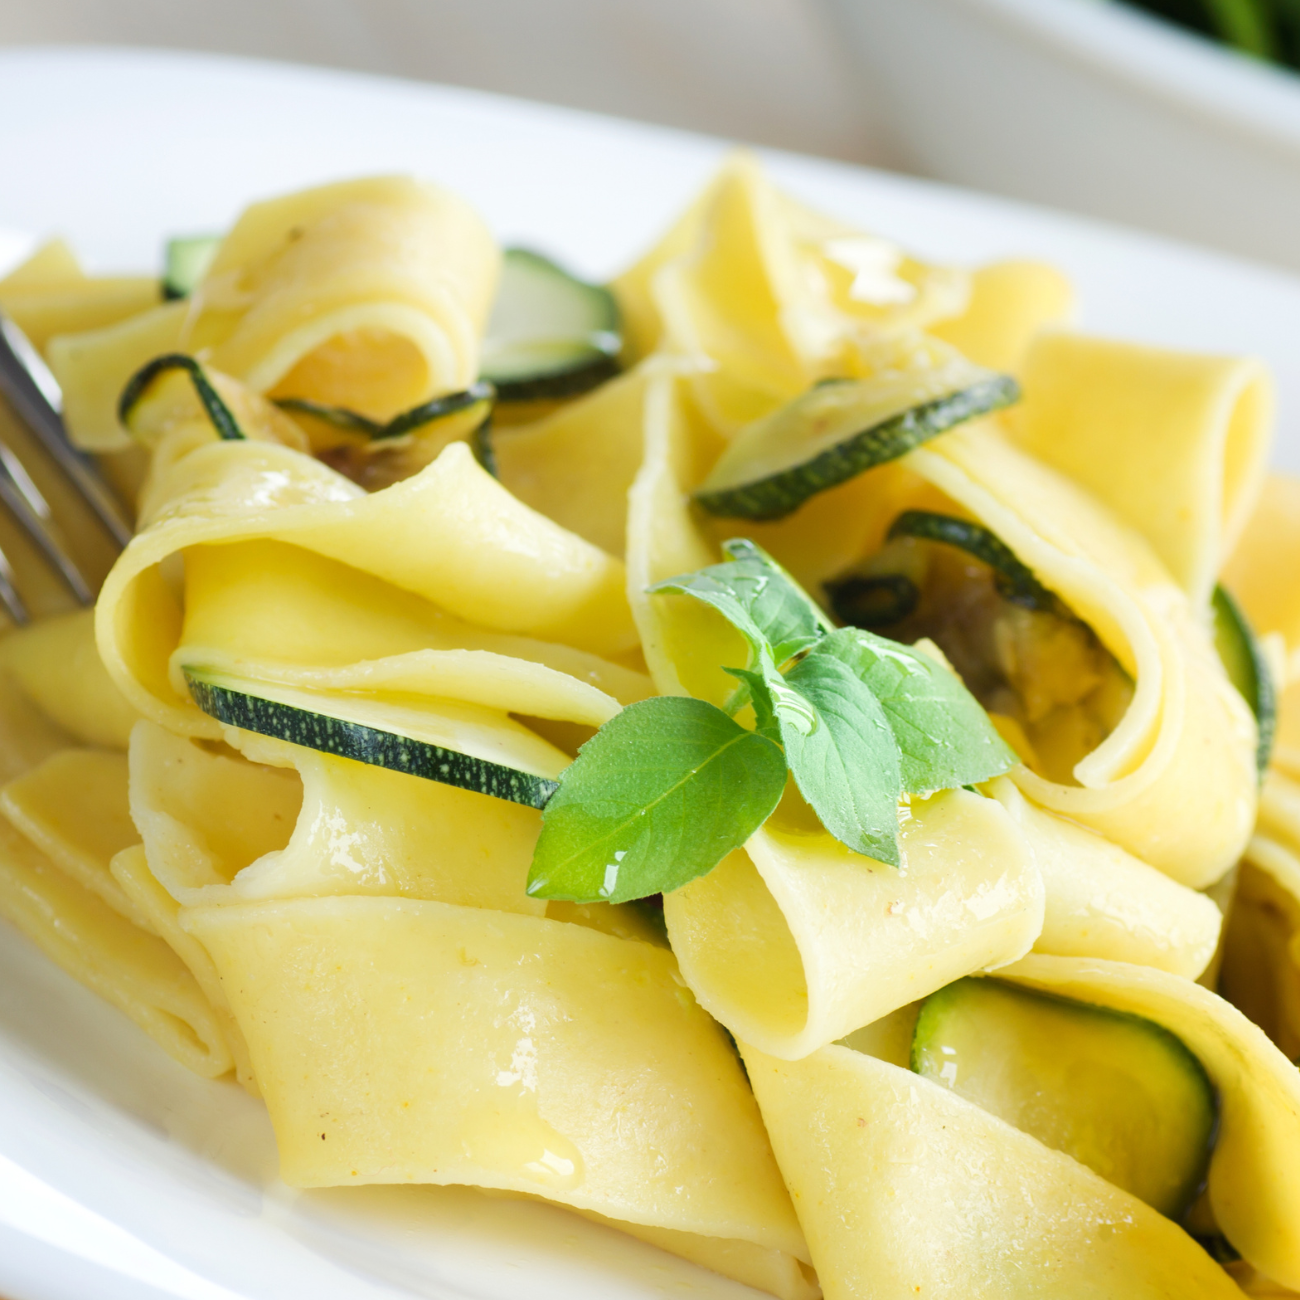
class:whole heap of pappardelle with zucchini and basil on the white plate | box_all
[0,155,1300,1300]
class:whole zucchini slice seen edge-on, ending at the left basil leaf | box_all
[183,666,568,809]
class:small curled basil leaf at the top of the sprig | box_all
[650,538,829,664]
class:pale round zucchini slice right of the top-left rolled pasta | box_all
[480,248,623,402]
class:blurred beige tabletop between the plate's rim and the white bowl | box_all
[0,0,887,163]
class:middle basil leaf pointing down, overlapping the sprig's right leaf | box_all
[767,633,902,866]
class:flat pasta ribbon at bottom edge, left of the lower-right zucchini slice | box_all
[742,1034,1240,1300]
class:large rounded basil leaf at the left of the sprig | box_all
[528,696,785,902]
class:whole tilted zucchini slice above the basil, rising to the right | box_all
[694,358,1021,519]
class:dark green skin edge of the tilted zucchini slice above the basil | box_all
[694,374,1021,520]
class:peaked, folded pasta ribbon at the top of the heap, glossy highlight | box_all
[612,153,969,434]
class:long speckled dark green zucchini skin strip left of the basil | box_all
[185,672,559,809]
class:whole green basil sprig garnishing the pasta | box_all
[528,540,1017,902]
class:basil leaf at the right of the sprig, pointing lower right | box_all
[818,628,1019,794]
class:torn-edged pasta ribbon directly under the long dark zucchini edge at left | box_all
[130,722,546,915]
